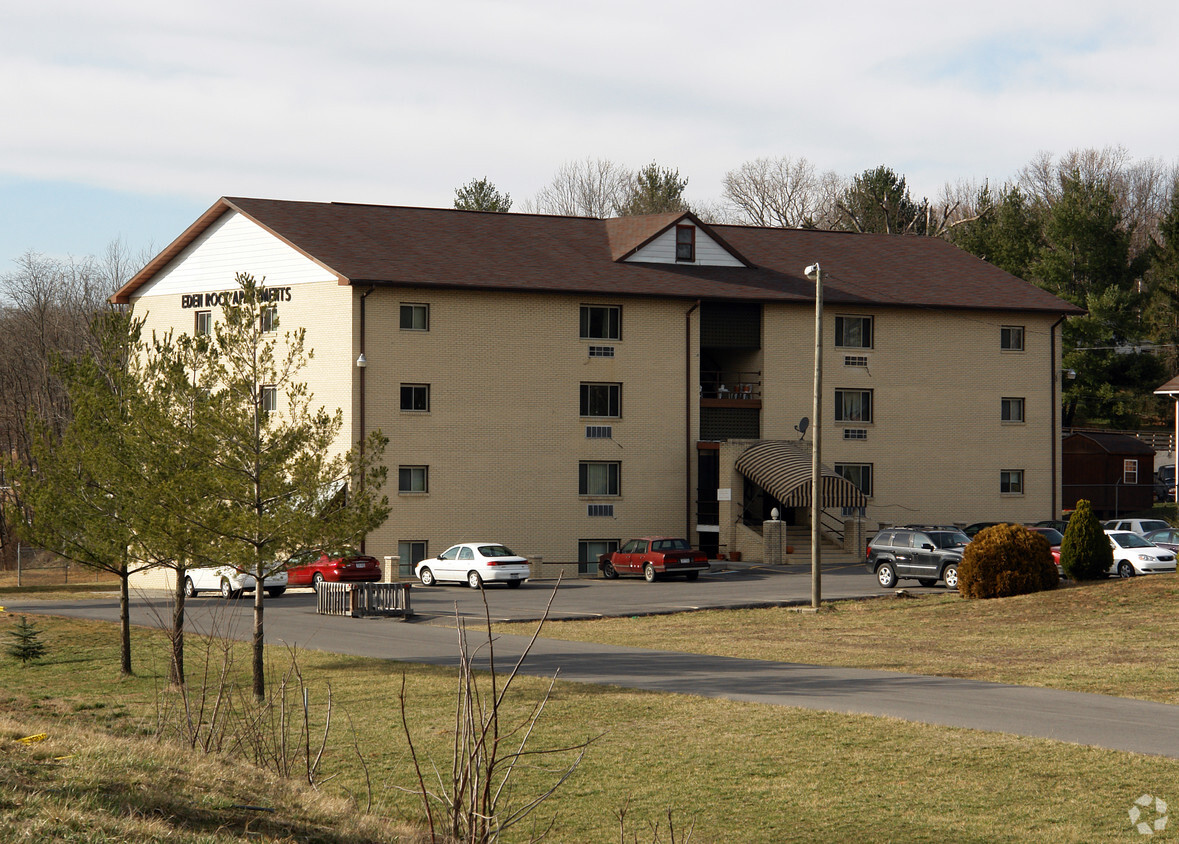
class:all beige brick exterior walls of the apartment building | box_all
[126,273,1059,566]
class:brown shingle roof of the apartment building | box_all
[113,198,1081,314]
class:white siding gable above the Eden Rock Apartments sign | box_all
[136,211,337,298]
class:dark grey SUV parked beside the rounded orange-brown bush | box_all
[864,527,970,589]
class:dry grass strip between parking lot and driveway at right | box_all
[498,574,1179,704]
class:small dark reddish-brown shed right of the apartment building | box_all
[1061,431,1154,519]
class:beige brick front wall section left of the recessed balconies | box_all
[367,289,694,563]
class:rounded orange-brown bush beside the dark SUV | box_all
[959,525,1060,598]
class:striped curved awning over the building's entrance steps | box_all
[737,440,868,508]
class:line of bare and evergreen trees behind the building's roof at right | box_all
[454,147,1179,429]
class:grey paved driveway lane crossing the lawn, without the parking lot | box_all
[6,589,1179,758]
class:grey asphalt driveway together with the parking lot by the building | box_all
[7,567,1179,758]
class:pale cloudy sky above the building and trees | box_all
[0,0,1179,272]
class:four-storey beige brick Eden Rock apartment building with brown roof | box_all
[114,199,1079,571]
